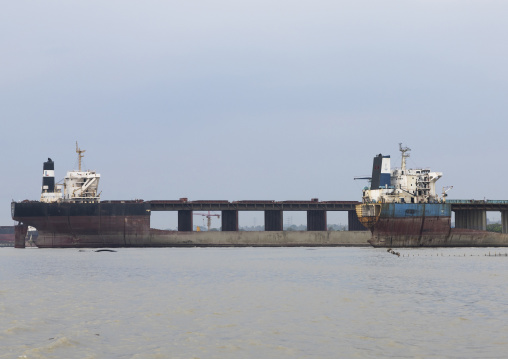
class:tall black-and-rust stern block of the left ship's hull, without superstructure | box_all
[11,201,150,248]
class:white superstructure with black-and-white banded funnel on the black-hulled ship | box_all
[41,143,101,203]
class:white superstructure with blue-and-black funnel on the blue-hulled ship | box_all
[363,144,445,203]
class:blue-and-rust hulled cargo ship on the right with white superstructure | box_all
[356,144,508,248]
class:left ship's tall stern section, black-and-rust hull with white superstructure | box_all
[11,143,150,248]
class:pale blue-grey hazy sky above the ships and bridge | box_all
[0,0,508,225]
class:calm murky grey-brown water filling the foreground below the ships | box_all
[0,248,508,358]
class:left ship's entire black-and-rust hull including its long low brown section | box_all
[11,201,370,248]
